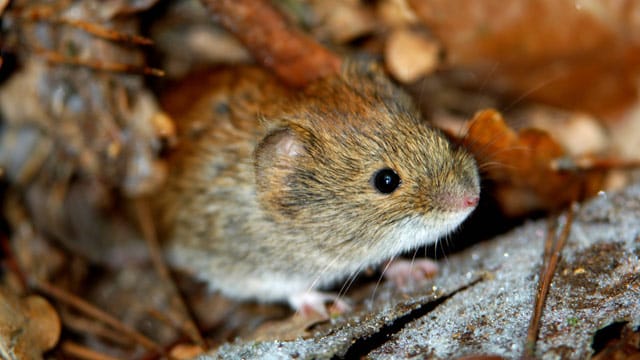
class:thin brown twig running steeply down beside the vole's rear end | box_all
[135,199,207,350]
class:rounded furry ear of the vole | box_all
[254,128,306,217]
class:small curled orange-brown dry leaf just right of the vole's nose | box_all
[464,110,603,216]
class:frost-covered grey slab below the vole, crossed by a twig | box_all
[208,184,640,359]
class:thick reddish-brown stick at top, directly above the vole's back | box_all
[201,0,341,87]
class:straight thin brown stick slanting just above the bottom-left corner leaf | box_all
[32,280,164,354]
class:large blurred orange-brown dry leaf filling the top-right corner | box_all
[409,0,640,114]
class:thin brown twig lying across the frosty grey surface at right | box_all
[523,203,578,360]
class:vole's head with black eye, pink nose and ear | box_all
[255,61,479,257]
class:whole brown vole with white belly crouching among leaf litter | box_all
[157,61,480,311]
